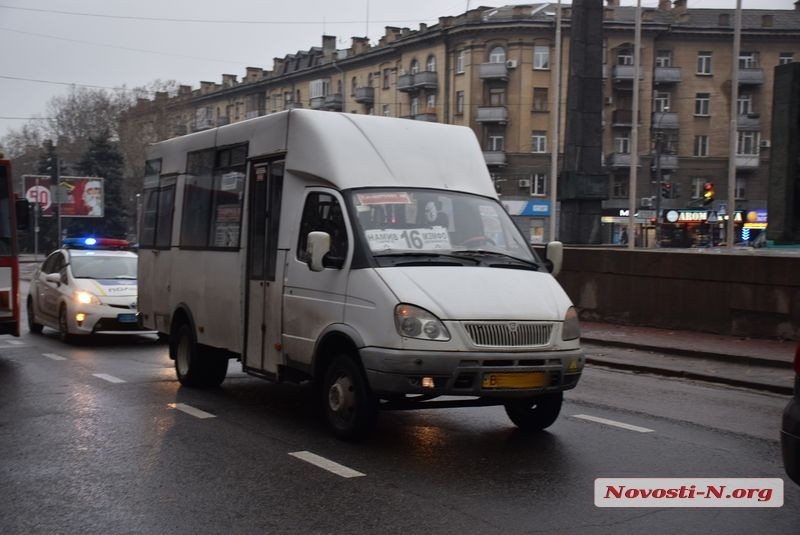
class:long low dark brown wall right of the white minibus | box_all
[558,247,800,340]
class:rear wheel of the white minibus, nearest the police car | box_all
[174,323,228,388]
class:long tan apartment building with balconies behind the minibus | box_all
[120,0,800,246]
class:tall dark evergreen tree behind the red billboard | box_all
[67,130,132,238]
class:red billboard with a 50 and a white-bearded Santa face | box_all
[23,175,105,217]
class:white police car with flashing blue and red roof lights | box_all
[27,238,150,341]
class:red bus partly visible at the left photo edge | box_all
[0,159,27,336]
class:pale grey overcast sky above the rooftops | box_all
[0,0,795,140]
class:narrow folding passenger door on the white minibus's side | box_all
[243,159,285,373]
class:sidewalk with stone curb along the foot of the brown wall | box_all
[581,321,798,395]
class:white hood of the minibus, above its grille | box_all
[376,266,572,321]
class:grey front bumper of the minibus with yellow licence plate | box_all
[360,347,586,398]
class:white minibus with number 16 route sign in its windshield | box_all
[139,109,584,439]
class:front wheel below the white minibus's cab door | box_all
[319,353,377,441]
